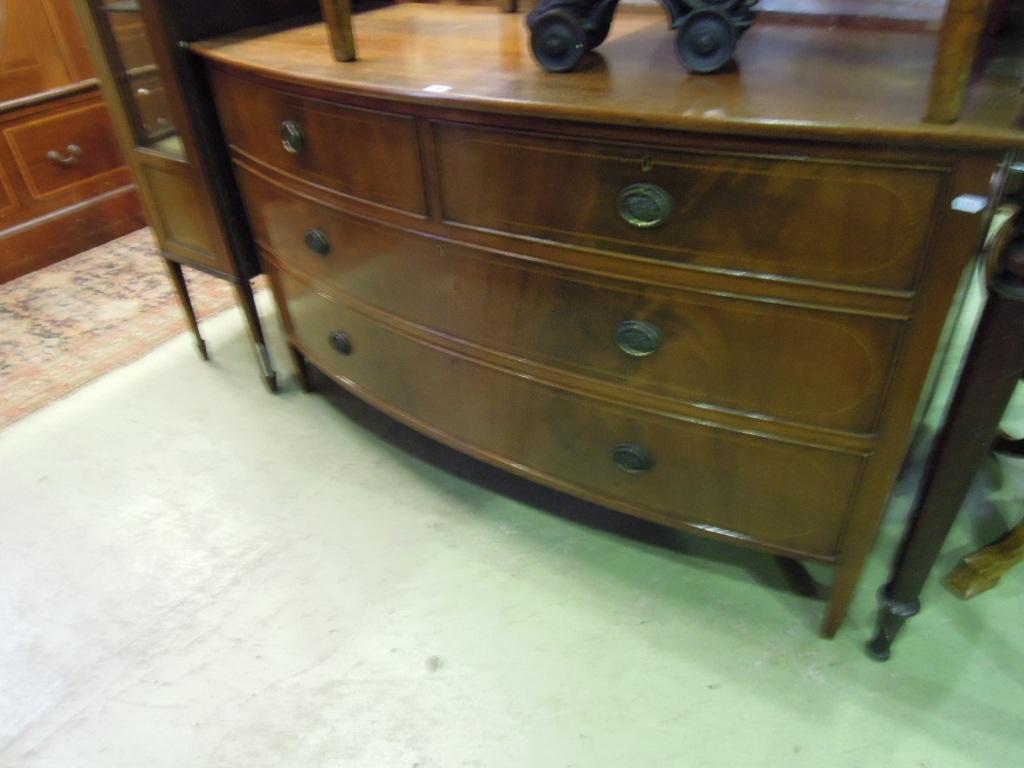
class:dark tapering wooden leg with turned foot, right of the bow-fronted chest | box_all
[867,236,1024,660]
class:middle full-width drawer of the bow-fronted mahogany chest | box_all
[239,170,902,432]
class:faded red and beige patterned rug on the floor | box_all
[0,229,234,429]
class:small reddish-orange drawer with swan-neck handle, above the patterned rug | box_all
[4,102,129,200]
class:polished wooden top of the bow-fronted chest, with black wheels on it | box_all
[193,3,1024,148]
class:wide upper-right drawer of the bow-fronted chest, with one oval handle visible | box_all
[434,123,943,291]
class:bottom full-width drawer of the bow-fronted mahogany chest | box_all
[275,271,862,556]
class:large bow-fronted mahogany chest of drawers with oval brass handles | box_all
[196,5,1024,635]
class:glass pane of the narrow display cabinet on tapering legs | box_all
[99,0,184,156]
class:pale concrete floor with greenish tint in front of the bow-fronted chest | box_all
[0,290,1024,768]
